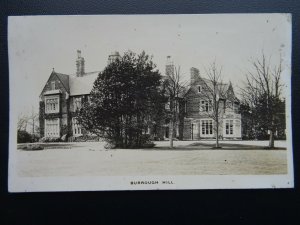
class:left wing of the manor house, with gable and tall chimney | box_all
[40,50,119,141]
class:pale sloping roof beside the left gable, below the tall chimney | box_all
[69,71,99,96]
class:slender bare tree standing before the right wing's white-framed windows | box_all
[200,61,227,148]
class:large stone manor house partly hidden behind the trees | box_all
[40,50,241,140]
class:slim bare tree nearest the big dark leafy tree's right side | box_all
[164,66,187,148]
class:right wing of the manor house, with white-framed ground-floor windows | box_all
[182,68,242,140]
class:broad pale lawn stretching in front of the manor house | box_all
[16,141,287,177]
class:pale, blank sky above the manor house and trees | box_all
[8,14,291,113]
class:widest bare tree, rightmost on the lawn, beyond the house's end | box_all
[242,52,282,148]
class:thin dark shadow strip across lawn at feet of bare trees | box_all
[150,142,286,151]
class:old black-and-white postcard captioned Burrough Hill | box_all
[8,13,294,192]
